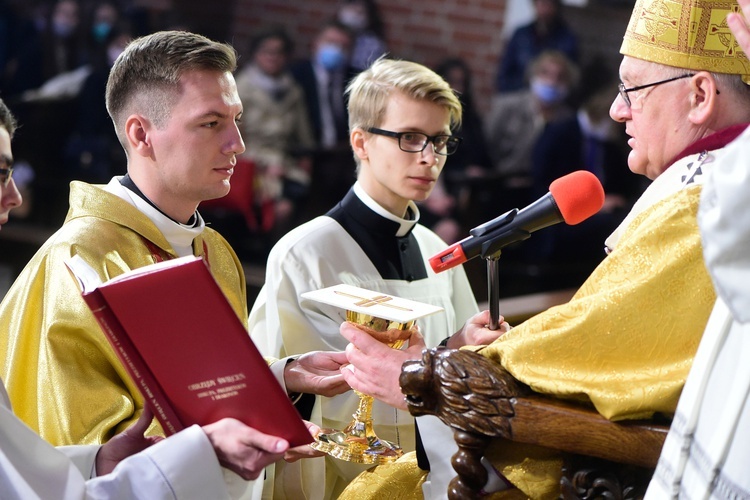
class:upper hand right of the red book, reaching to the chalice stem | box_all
[284,351,349,397]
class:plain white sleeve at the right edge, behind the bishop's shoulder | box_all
[698,128,750,323]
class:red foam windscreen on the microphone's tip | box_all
[549,170,604,226]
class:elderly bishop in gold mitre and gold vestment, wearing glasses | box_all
[340,0,750,500]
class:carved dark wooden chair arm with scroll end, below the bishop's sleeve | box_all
[401,348,669,500]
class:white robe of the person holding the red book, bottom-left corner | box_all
[0,404,228,500]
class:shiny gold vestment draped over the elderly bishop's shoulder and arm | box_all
[479,186,715,420]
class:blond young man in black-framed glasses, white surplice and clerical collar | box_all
[249,59,506,498]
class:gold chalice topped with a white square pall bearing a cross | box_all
[303,285,442,464]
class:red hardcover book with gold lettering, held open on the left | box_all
[66,255,313,447]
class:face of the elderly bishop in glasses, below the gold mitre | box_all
[609,56,697,180]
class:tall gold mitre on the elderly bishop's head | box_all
[620,0,750,83]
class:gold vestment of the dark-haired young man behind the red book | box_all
[0,182,247,445]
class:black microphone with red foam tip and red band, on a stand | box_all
[430,170,604,273]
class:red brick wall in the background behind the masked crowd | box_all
[230,0,632,121]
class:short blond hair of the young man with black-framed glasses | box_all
[346,57,462,131]
